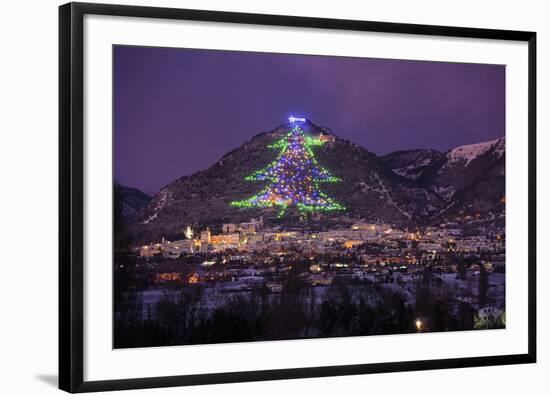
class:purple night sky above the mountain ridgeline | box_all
[114,46,505,193]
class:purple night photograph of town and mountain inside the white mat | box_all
[112,44,508,349]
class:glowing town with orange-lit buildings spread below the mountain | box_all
[115,216,505,341]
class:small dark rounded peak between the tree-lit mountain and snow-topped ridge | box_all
[380,149,443,180]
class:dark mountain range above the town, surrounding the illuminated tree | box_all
[123,121,504,242]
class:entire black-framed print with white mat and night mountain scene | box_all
[59,3,536,392]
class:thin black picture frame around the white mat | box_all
[59,3,536,392]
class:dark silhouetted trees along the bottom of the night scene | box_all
[114,279,484,348]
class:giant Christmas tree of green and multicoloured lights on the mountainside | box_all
[231,117,344,218]
